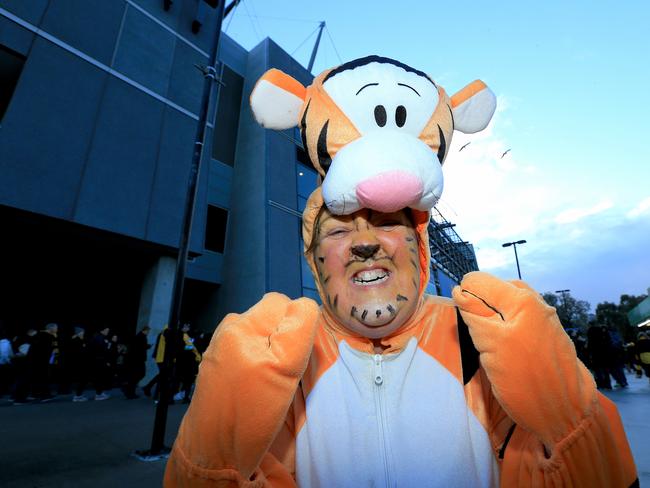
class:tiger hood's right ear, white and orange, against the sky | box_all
[451,80,497,134]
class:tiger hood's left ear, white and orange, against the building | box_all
[250,69,306,130]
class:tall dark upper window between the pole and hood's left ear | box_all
[212,64,244,166]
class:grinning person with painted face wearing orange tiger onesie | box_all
[164,56,638,487]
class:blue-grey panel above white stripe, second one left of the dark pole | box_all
[113,7,177,96]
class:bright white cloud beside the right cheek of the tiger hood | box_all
[438,97,650,306]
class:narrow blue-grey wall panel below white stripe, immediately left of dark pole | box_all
[146,107,191,247]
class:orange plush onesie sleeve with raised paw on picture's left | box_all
[164,293,318,487]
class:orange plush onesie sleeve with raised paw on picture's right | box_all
[453,272,638,488]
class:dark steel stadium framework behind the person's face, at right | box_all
[428,207,478,286]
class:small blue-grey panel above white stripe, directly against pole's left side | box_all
[167,41,208,114]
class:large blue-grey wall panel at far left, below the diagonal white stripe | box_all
[0,38,108,218]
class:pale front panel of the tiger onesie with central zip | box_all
[296,339,498,488]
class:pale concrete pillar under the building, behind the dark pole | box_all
[138,256,176,385]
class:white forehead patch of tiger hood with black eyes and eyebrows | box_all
[323,61,439,137]
